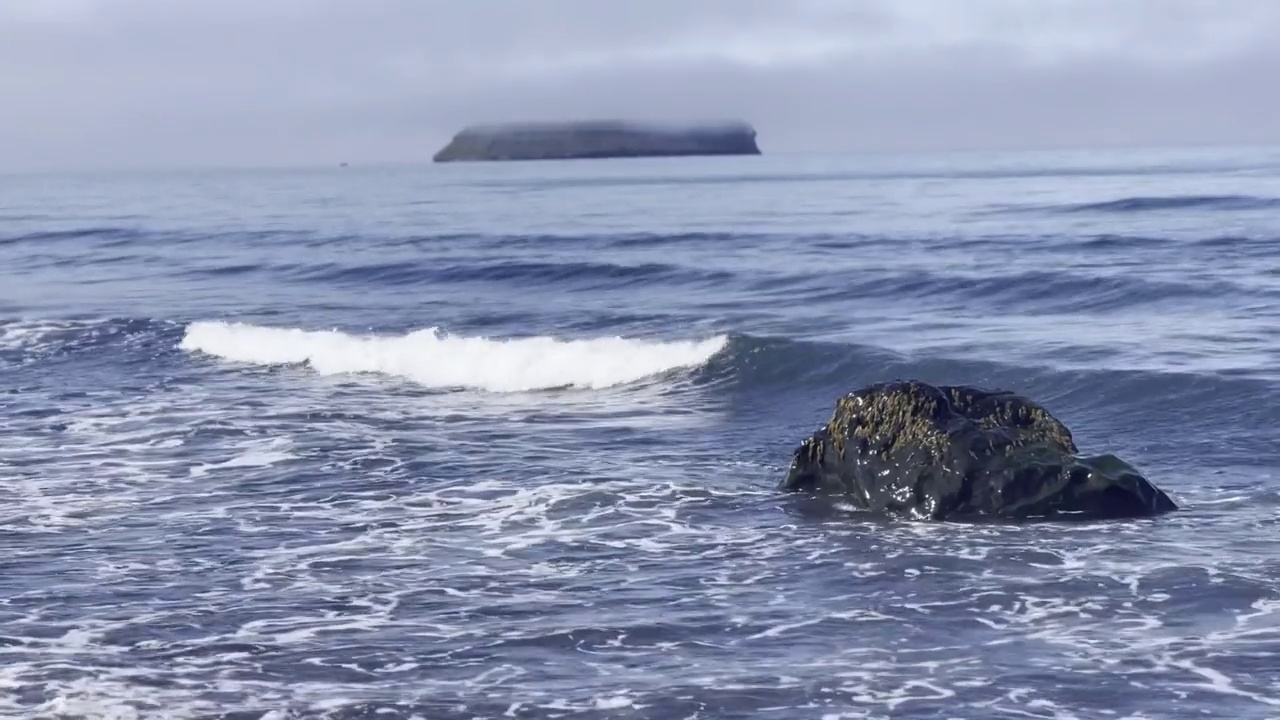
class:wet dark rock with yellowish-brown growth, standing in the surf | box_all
[780,380,1178,520]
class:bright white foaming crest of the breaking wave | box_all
[180,322,727,392]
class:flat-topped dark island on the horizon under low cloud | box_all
[435,120,760,163]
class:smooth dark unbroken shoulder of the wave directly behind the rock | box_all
[695,336,1280,465]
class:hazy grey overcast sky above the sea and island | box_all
[0,0,1280,170]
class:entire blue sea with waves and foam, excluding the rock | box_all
[0,150,1280,720]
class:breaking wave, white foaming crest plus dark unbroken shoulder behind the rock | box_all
[160,316,1280,464]
